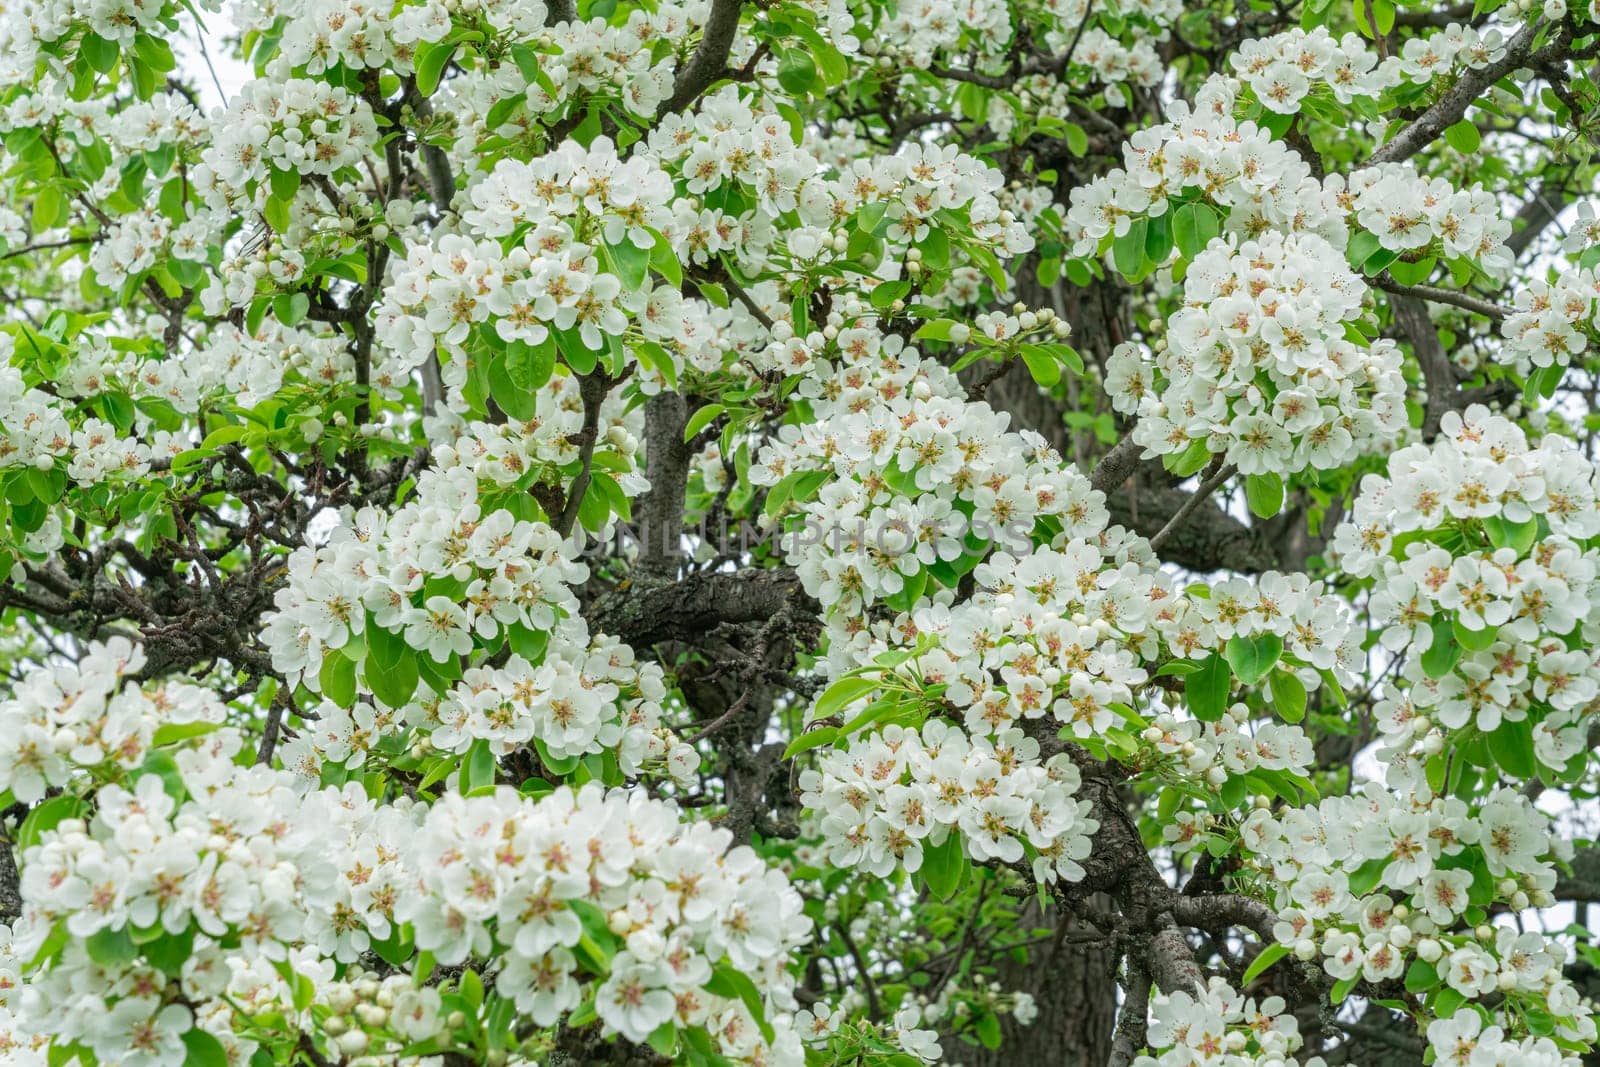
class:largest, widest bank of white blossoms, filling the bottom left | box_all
[8,716,810,1067]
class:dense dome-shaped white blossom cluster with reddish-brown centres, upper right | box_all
[1106,230,1406,475]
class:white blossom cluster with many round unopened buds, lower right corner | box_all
[1238,771,1595,1041]
